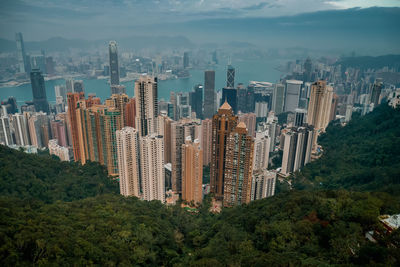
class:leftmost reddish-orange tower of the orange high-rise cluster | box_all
[67,92,85,161]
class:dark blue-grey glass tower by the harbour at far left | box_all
[31,69,49,113]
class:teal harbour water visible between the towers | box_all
[0,59,284,105]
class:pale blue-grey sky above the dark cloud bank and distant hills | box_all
[0,0,400,40]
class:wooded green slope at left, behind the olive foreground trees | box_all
[0,145,119,203]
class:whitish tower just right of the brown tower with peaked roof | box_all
[253,131,271,170]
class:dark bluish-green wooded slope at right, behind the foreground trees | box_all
[294,105,400,196]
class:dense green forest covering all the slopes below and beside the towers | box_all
[0,105,400,266]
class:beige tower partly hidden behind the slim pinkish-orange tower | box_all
[171,120,201,193]
